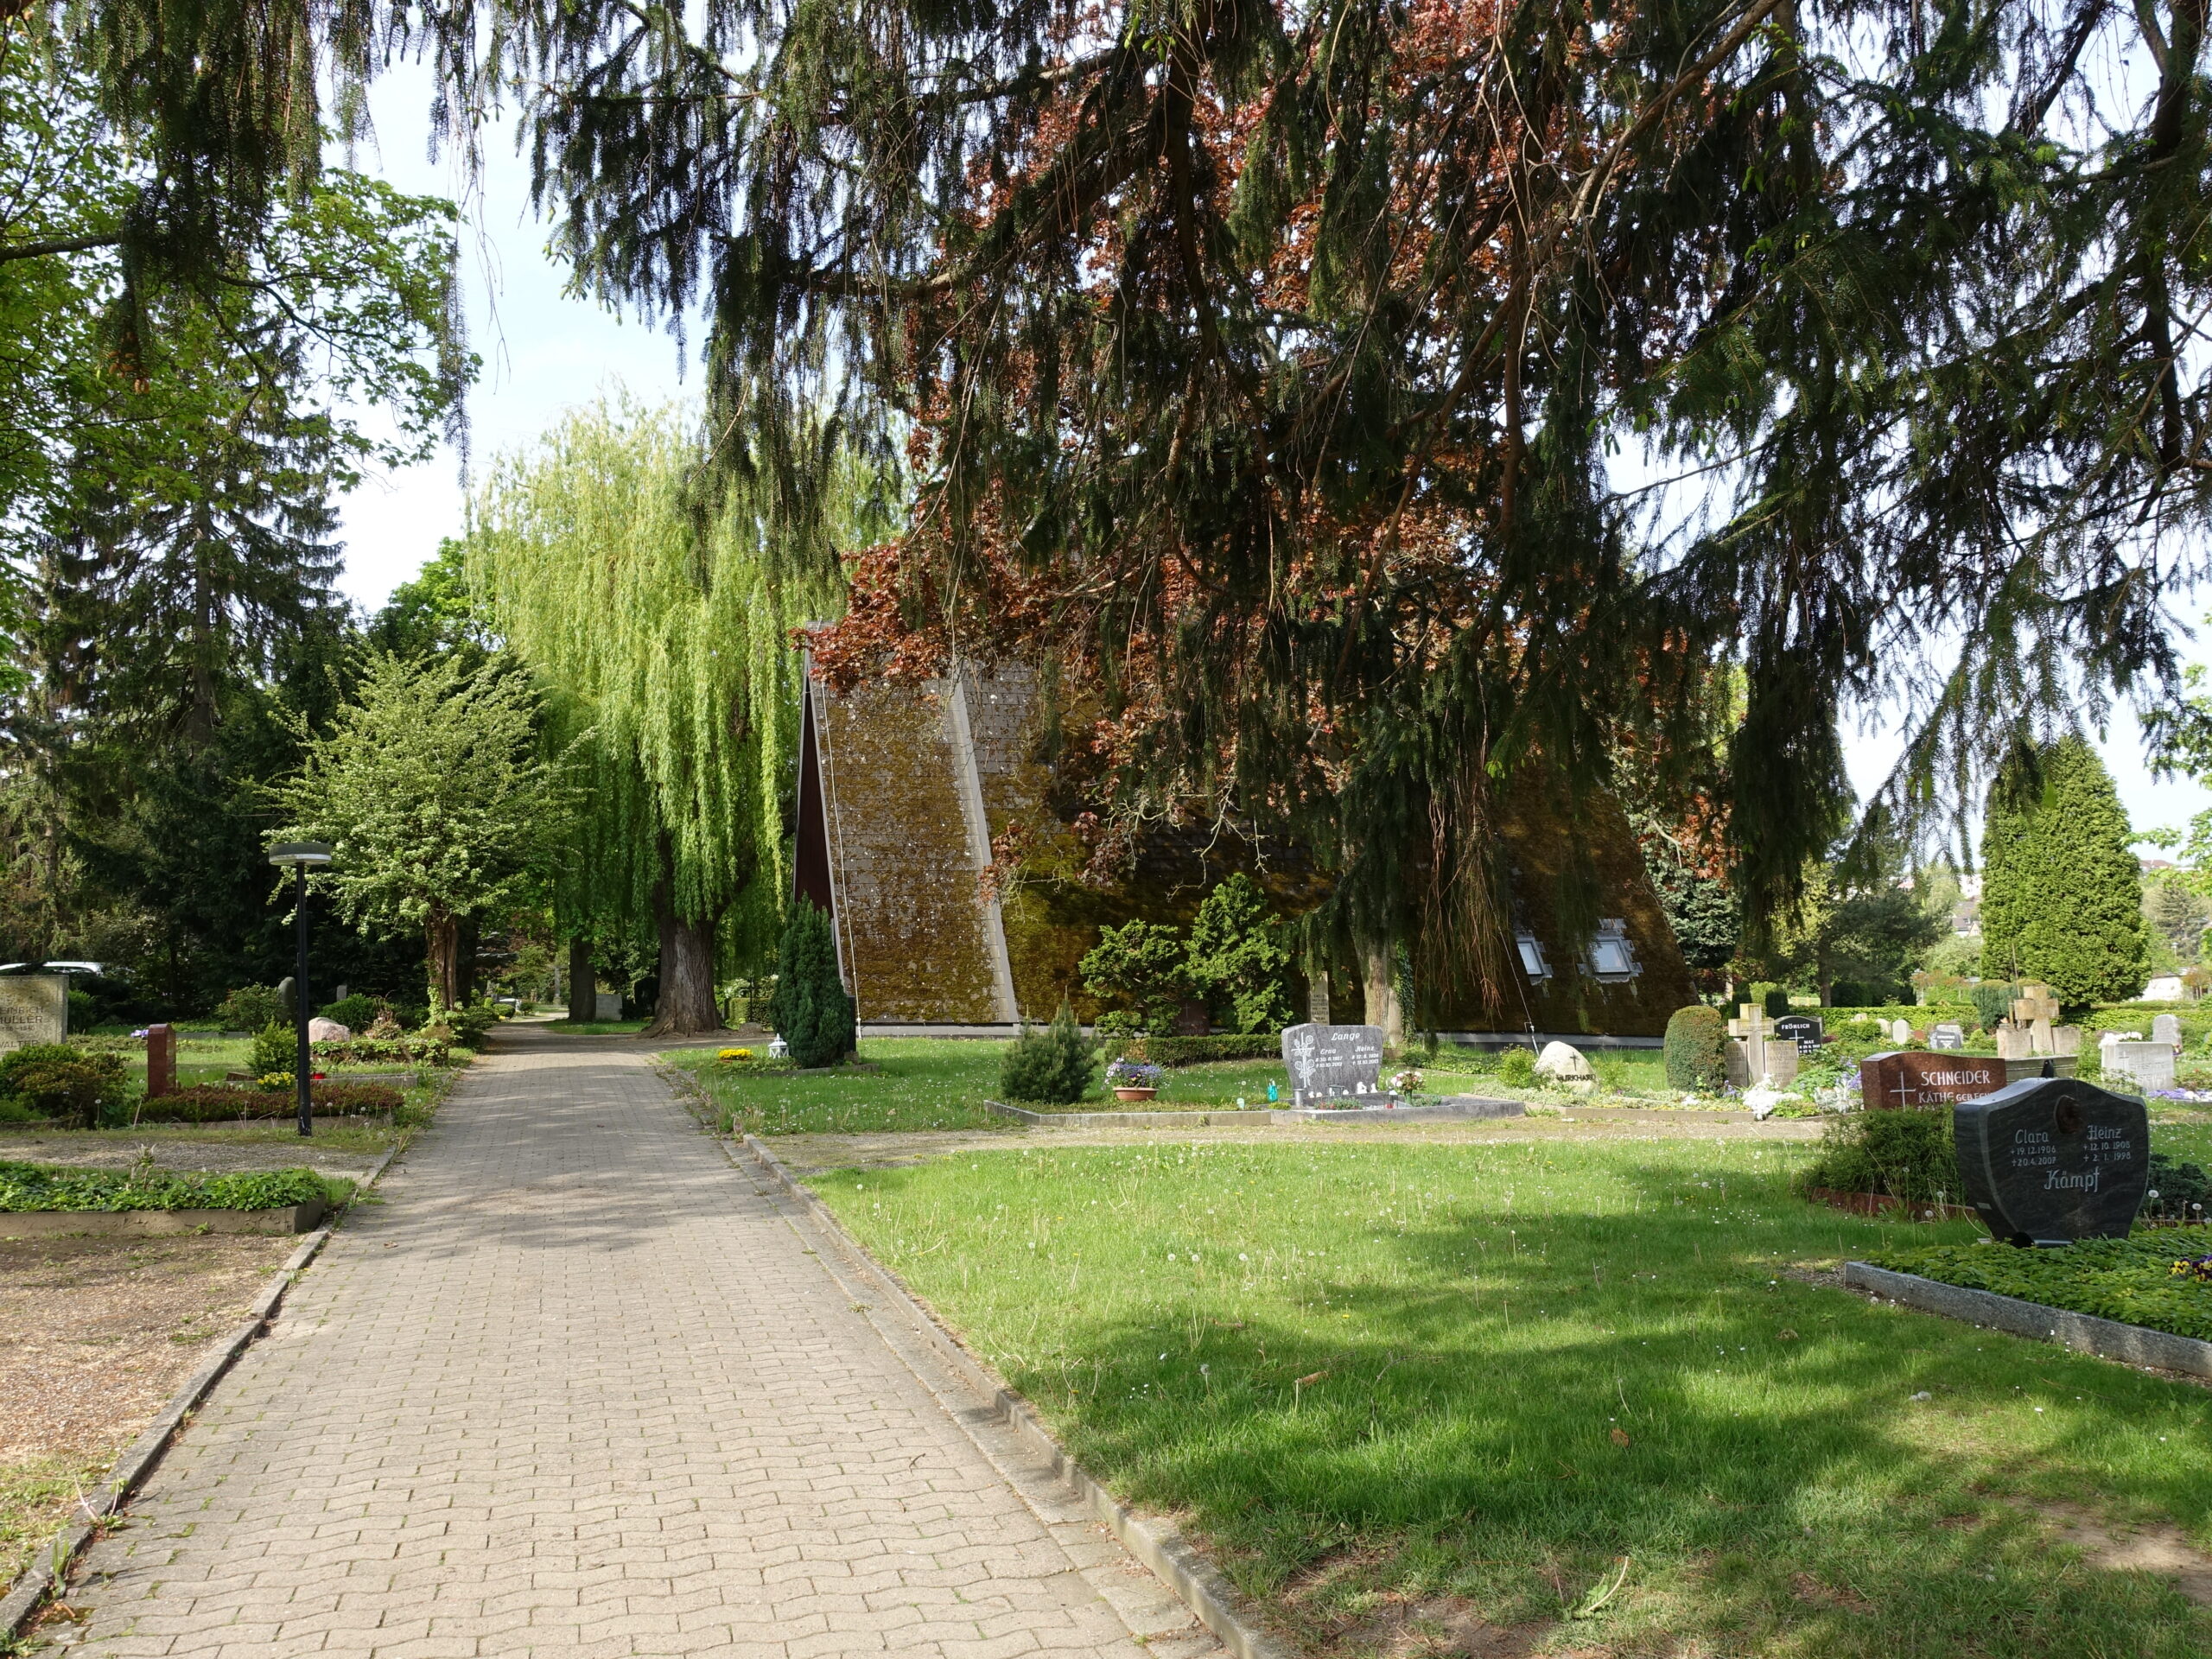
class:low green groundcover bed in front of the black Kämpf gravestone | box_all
[1867,1238,2212,1340]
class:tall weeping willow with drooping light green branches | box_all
[467,403,868,1033]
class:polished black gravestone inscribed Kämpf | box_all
[1951,1077,2150,1245]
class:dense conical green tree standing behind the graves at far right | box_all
[1982,736,2150,1007]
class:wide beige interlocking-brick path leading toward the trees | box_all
[48,1038,1212,1659]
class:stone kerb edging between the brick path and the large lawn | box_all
[743,1141,1296,1659]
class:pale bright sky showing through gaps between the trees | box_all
[322,68,2212,849]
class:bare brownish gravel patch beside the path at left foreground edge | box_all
[0,1234,299,1584]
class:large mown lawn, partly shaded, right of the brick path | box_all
[814,1141,2212,1659]
